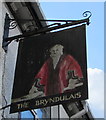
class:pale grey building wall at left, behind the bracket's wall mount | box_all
[0,2,20,118]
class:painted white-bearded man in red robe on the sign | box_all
[29,44,83,96]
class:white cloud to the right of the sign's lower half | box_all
[87,68,104,116]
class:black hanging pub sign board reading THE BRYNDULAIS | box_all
[10,25,88,113]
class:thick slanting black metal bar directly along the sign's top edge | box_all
[5,18,89,41]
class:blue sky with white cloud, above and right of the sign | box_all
[40,0,104,118]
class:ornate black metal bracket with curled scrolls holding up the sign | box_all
[3,11,92,51]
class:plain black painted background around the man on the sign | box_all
[12,25,88,102]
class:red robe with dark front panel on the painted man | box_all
[35,55,82,96]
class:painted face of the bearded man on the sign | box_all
[50,45,63,57]
